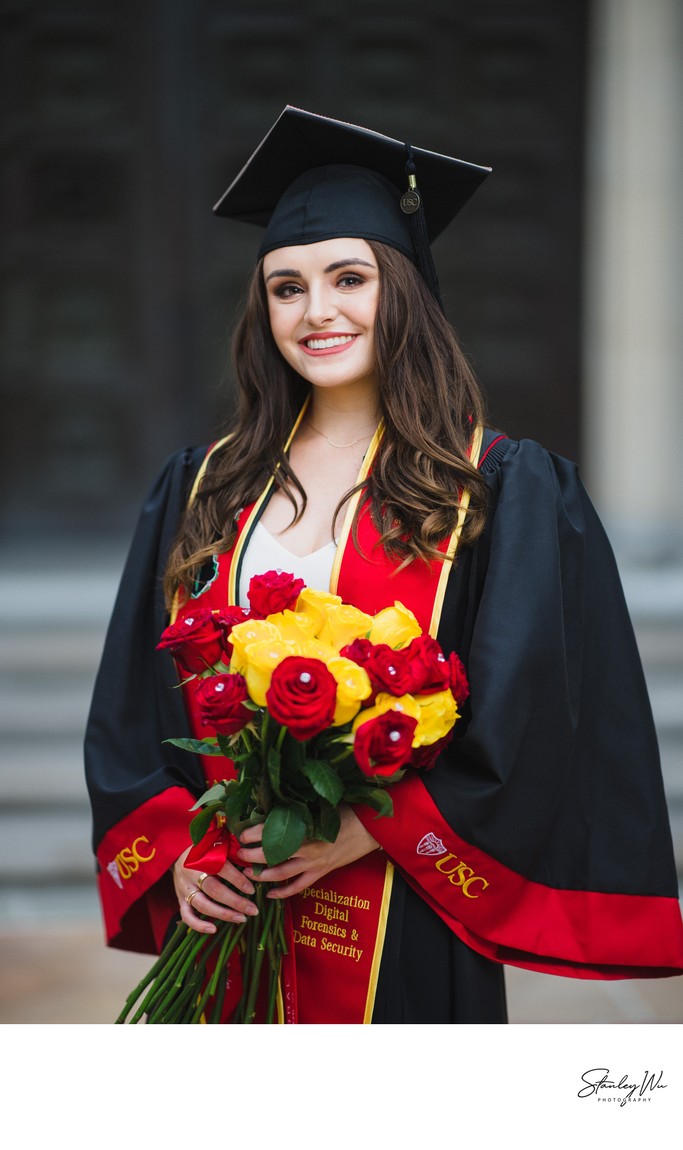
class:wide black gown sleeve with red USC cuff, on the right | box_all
[359,440,683,979]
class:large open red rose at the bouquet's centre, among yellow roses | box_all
[266,654,337,742]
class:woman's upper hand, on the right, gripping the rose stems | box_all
[235,805,379,903]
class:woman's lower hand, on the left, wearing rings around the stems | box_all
[171,848,259,934]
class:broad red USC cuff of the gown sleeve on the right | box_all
[355,774,683,979]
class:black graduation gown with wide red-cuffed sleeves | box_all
[86,435,683,1022]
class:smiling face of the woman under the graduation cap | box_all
[263,239,379,402]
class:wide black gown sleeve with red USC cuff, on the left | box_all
[85,449,206,952]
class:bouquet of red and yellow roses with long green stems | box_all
[117,572,468,1024]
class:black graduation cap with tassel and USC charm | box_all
[214,105,491,299]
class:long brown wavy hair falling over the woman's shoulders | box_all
[164,243,486,604]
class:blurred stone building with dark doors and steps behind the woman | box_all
[0,0,683,1025]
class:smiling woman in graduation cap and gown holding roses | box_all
[86,108,683,1022]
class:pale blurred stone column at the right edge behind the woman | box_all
[583,0,683,562]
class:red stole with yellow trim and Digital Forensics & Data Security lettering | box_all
[172,412,481,1024]
